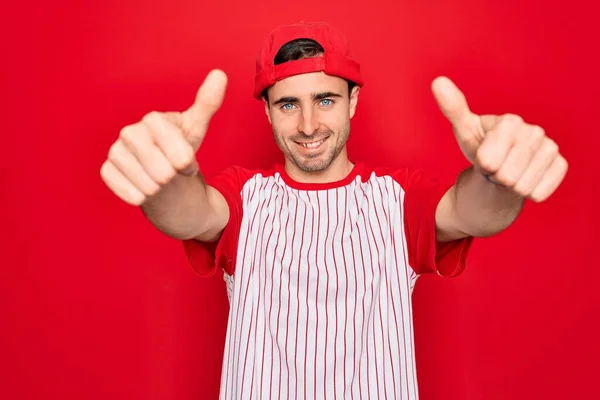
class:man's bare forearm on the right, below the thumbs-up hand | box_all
[451,167,524,237]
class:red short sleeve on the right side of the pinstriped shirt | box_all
[396,169,473,277]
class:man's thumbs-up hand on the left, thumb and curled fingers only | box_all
[100,70,227,205]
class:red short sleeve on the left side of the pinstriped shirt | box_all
[182,167,243,277]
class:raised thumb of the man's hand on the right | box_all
[431,76,478,136]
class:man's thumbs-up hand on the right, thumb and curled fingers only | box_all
[432,77,568,202]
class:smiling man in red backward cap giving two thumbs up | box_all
[101,23,567,399]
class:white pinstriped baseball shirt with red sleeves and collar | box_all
[184,163,471,400]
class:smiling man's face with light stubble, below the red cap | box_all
[265,72,359,172]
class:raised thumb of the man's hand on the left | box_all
[181,69,227,150]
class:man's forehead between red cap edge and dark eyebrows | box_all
[268,72,348,98]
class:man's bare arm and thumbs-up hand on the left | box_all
[100,70,229,241]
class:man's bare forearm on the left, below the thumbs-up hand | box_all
[141,170,220,239]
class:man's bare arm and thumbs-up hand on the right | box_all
[432,77,568,241]
